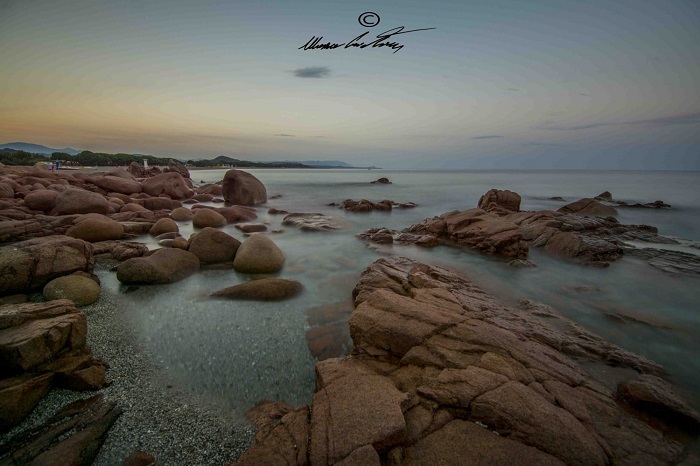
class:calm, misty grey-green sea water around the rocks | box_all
[101,169,700,412]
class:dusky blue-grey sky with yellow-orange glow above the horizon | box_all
[0,0,700,170]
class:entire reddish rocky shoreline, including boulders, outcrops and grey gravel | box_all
[0,166,700,465]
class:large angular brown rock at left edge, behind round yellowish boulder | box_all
[0,235,93,294]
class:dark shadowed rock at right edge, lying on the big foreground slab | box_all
[617,374,700,432]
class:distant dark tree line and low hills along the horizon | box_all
[0,148,377,168]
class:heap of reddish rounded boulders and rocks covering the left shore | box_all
[0,162,301,464]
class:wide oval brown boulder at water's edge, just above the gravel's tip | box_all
[117,248,199,285]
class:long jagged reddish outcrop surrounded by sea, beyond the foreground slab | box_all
[358,189,700,274]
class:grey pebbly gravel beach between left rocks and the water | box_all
[0,288,254,465]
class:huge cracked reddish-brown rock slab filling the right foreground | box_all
[234,257,700,465]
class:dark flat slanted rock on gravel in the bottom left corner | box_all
[0,395,122,466]
